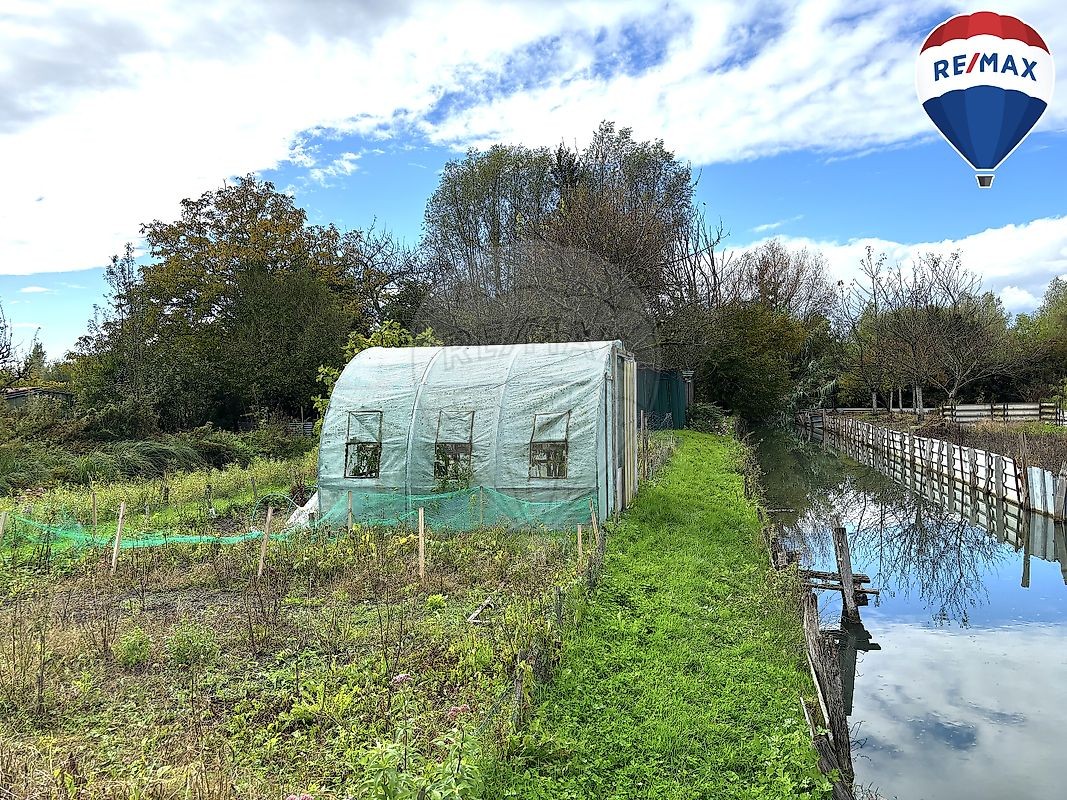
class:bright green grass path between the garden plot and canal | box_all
[485,433,829,800]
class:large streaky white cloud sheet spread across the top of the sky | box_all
[0,0,1067,274]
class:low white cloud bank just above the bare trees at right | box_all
[749,217,1067,313]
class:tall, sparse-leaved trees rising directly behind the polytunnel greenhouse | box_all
[418,123,692,361]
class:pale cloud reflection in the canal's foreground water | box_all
[851,623,1067,800]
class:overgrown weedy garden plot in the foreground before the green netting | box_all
[0,486,589,800]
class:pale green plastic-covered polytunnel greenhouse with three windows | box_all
[318,341,638,527]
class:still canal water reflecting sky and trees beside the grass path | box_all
[753,430,1067,800]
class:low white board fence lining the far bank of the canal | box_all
[799,412,1067,519]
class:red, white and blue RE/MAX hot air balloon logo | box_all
[915,11,1055,189]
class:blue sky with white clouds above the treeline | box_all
[0,0,1067,357]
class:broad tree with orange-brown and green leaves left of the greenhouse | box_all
[75,176,414,429]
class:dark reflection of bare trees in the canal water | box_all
[765,438,1005,626]
